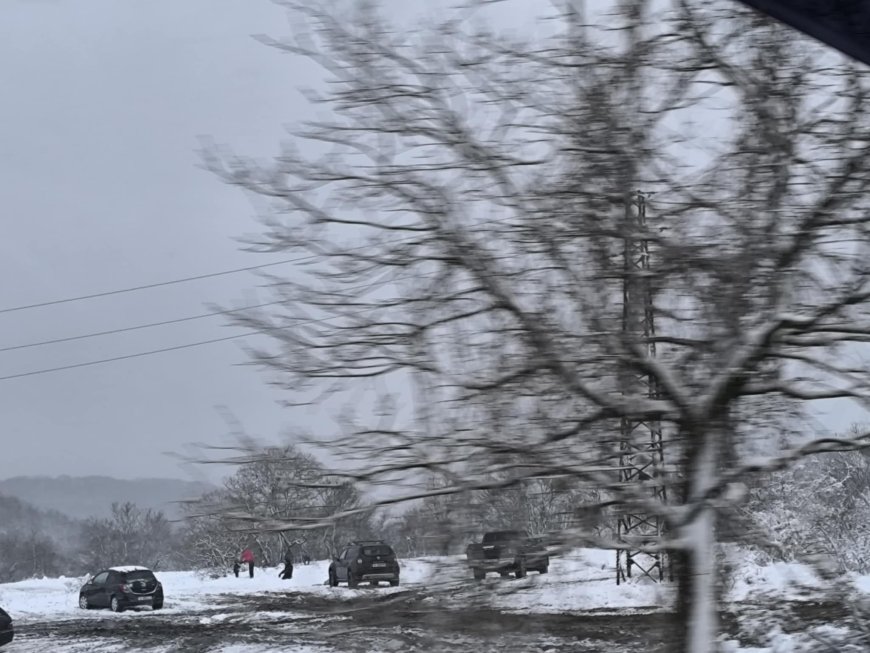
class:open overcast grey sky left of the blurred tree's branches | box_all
[0,0,855,478]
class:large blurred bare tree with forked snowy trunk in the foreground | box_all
[206,0,870,652]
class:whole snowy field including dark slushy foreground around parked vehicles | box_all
[0,549,870,653]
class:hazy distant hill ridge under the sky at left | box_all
[0,476,214,519]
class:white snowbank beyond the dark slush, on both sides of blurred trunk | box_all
[0,549,870,621]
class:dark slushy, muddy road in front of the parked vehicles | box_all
[4,586,860,653]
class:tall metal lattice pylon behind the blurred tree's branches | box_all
[616,192,667,584]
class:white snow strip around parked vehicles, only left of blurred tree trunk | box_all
[0,549,671,623]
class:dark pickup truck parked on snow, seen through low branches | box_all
[465,531,550,580]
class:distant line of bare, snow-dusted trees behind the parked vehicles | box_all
[0,438,870,582]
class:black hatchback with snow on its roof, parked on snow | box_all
[79,567,163,612]
